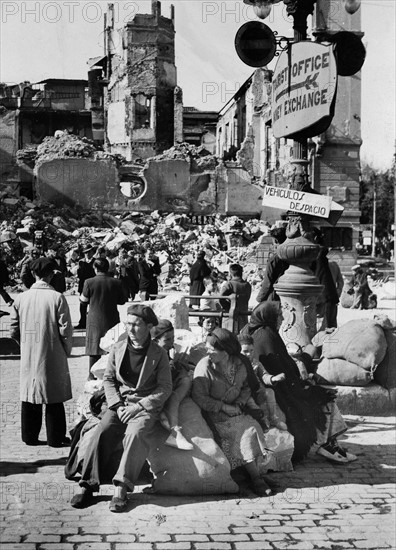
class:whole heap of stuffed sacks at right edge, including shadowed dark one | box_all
[313,315,396,389]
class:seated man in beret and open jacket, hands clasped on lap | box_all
[71,304,172,512]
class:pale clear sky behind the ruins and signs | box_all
[0,0,396,170]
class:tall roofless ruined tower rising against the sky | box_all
[104,0,183,161]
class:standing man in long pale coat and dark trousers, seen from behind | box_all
[10,258,73,447]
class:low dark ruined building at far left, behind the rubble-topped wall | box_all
[0,78,92,196]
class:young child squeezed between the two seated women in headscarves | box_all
[238,334,287,430]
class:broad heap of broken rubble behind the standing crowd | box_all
[0,187,268,290]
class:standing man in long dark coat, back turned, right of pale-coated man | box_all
[80,258,127,380]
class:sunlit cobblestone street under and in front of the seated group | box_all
[0,297,396,550]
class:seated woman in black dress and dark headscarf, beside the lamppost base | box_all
[242,302,357,463]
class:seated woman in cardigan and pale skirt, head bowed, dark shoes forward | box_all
[192,328,272,496]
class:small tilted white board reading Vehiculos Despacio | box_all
[263,185,332,218]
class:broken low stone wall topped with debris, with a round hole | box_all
[35,135,262,216]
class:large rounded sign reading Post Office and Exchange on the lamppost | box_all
[272,41,337,138]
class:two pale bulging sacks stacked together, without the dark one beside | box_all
[312,319,387,386]
